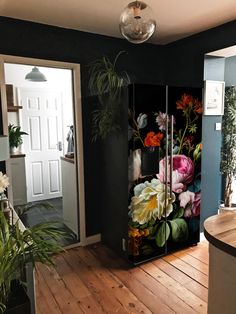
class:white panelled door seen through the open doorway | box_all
[18,88,62,202]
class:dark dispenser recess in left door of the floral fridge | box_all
[141,146,160,176]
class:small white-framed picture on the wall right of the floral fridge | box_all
[203,80,225,116]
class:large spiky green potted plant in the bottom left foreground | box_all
[0,200,65,314]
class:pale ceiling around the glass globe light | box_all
[0,0,236,44]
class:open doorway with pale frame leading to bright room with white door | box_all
[0,57,85,245]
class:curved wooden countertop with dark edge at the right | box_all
[204,211,236,257]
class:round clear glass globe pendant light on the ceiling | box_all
[119,1,156,44]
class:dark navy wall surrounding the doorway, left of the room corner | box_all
[0,17,165,236]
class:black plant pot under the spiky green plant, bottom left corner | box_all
[4,281,31,314]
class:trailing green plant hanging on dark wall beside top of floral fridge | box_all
[89,51,130,141]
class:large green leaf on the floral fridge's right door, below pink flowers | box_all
[170,218,188,242]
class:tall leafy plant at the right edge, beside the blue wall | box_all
[221,86,236,208]
